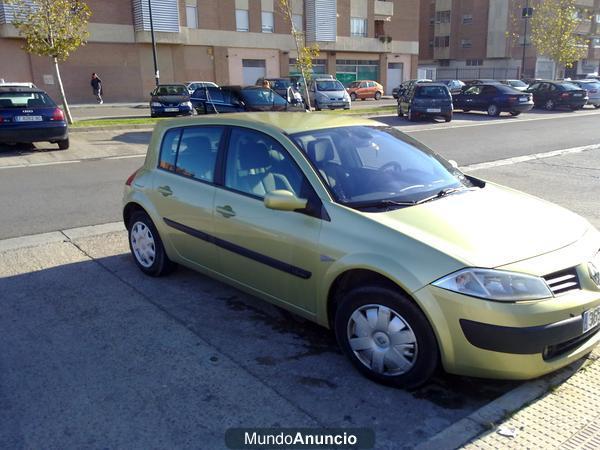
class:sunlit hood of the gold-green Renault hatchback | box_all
[369,183,590,267]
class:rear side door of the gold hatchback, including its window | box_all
[151,126,225,270]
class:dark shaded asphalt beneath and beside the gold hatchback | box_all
[0,248,515,448]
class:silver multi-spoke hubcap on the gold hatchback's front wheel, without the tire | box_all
[347,304,418,376]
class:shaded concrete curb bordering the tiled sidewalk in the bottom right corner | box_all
[414,355,599,450]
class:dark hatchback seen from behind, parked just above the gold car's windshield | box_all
[398,83,453,122]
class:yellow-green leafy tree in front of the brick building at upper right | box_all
[519,0,589,78]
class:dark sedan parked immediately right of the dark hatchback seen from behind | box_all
[452,83,533,116]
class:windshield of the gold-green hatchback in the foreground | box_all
[292,126,471,207]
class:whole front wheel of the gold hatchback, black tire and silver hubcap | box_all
[335,286,439,388]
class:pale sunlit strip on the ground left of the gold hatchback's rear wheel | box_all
[0,222,125,253]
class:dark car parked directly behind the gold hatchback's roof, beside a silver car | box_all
[191,86,305,114]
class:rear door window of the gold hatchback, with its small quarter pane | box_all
[159,126,225,182]
